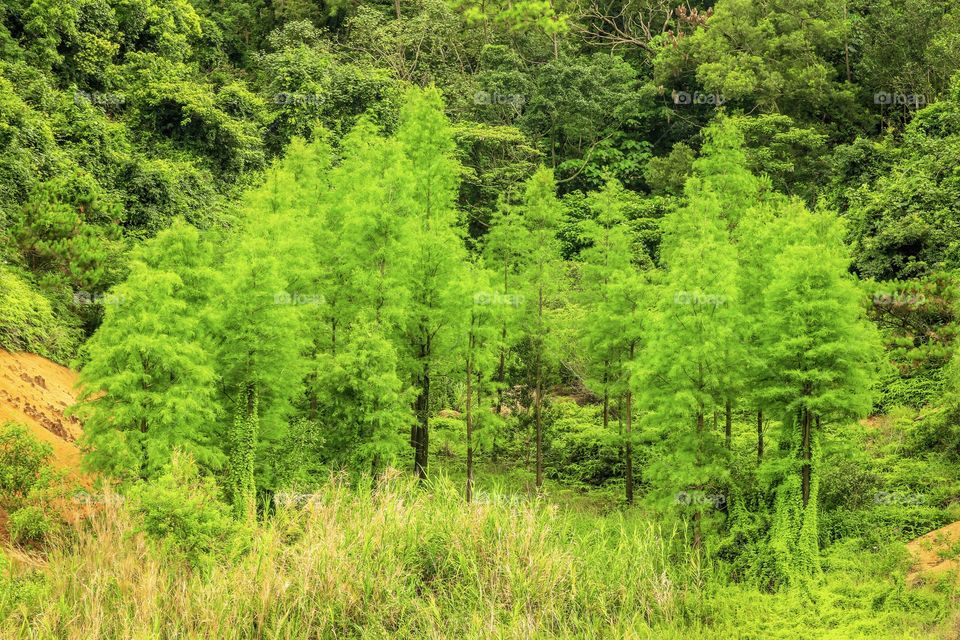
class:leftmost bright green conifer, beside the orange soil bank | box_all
[76,221,224,479]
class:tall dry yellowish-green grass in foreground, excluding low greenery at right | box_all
[0,476,705,640]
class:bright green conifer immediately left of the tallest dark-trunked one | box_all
[309,119,412,473]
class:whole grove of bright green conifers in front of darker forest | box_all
[78,88,882,575]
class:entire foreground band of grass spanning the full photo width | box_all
[0,475,956,639]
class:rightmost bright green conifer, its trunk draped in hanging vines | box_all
[765,202,881,581]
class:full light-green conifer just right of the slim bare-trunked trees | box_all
[633,178,740,547]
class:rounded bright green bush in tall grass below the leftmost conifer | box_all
[130,452,248,569]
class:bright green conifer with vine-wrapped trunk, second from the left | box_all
[216,165,312,519]
